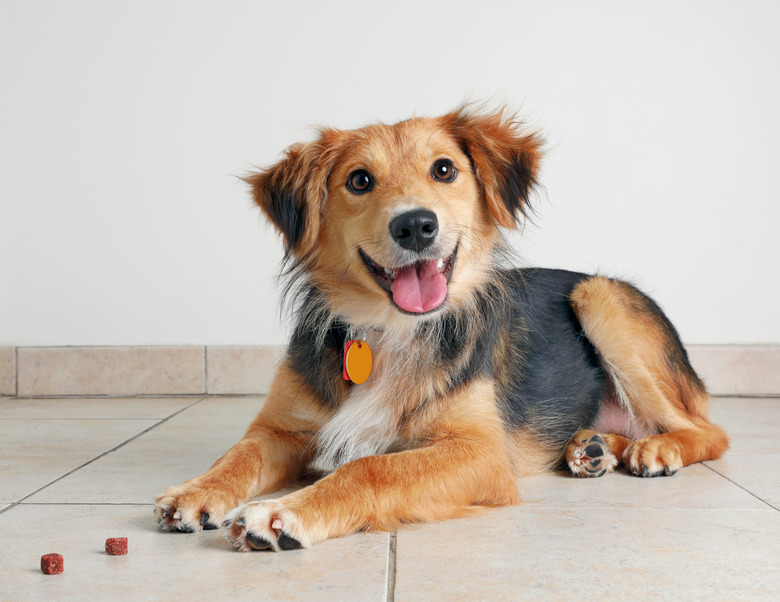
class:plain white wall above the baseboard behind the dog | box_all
[0,0,780,345]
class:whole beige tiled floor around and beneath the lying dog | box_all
[0,397,780,601]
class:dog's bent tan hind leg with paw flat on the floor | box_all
[571,276,728,477]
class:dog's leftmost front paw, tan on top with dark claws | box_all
[154,479,240,533]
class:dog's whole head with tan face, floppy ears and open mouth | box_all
[247,109,541,326]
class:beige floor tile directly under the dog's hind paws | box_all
[519,464,766,510]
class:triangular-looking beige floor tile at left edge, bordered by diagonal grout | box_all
[0,420,157,502]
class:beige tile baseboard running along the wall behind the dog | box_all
[0,345,780,397]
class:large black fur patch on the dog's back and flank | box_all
[418,269,607,446]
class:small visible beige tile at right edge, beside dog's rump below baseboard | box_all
[710,397,780,454]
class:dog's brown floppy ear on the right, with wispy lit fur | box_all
[442,108,542,228]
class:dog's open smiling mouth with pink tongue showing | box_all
[358,247,458,314]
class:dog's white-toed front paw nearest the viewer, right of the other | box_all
[222,500,312,552]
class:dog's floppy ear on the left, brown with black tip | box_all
[245,131,335,258]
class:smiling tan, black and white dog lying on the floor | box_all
[155,107,728,551]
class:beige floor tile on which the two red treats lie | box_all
[0,505,388,601]
